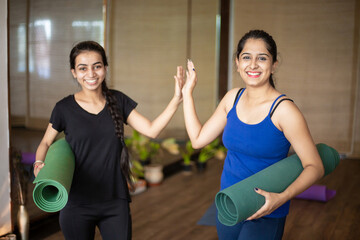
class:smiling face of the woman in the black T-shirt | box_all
[71,51,106,91]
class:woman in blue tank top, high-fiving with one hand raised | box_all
[182,30,324,240]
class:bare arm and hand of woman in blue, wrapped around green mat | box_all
[248,101,324,220]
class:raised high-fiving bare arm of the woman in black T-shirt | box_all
[127,67,183,138]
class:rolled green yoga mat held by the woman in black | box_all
[33,138,75,212]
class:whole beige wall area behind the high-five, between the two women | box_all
[109,0,217,138]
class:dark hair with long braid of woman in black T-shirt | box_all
[70,41,133,188]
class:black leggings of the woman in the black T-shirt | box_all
[60,199,131,240]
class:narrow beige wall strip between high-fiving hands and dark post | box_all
[189,0,219,123]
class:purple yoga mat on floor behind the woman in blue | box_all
[295,185,336,202]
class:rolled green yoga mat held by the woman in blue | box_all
[215,143,340,226]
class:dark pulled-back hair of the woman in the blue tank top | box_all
[235,30,277,88]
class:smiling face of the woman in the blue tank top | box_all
[236,38,277,87]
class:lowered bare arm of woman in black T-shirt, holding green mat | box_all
[34,123,59,177]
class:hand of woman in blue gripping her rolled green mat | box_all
[246,188,286,221]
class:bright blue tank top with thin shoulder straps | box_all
[220,89,290,218]
